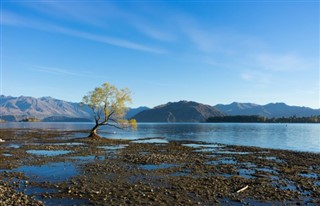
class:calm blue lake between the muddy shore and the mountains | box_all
[0,122,320,153]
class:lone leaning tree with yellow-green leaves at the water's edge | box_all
[82,83,137,139]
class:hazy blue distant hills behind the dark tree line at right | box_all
[214,102,320,118]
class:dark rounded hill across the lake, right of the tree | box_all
[133,101,224,122]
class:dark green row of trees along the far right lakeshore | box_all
[207,115,320,123]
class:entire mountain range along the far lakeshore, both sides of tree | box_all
[0,95,320,122]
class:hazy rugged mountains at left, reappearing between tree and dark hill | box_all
[0,95,149,122]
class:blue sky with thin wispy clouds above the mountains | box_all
[1,0,320,108]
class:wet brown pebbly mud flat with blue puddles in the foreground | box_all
[0,129,320,205]
